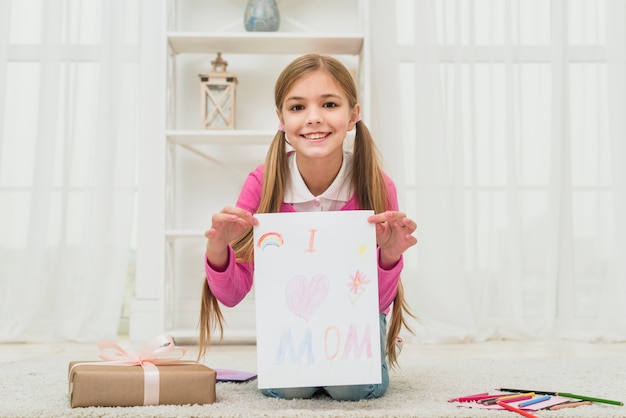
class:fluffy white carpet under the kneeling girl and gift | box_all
[0,353,626,418]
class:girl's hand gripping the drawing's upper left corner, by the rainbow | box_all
[204,206,259,267]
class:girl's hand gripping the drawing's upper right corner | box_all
[367,210,417,268]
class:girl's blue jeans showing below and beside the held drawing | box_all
[261,313,389,401]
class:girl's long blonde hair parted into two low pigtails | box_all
[198,54,415,366]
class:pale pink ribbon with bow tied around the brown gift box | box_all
[70,335,187,405]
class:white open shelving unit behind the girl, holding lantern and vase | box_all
[130,0,369,342]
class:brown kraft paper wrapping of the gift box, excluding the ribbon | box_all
[68,361,217,408]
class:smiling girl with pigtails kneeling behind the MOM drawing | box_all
[199,54,417,400]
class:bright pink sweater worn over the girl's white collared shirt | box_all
[204,165,403,313]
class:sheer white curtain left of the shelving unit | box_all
[0,0,159,341]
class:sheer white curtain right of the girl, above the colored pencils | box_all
[370,0,626,342]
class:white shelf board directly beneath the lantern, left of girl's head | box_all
[165,129,276,146]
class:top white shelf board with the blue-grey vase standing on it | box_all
[167,32,363,55]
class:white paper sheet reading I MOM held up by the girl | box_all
[254,211,381,389]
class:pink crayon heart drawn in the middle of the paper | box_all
[285,274,330,321]
